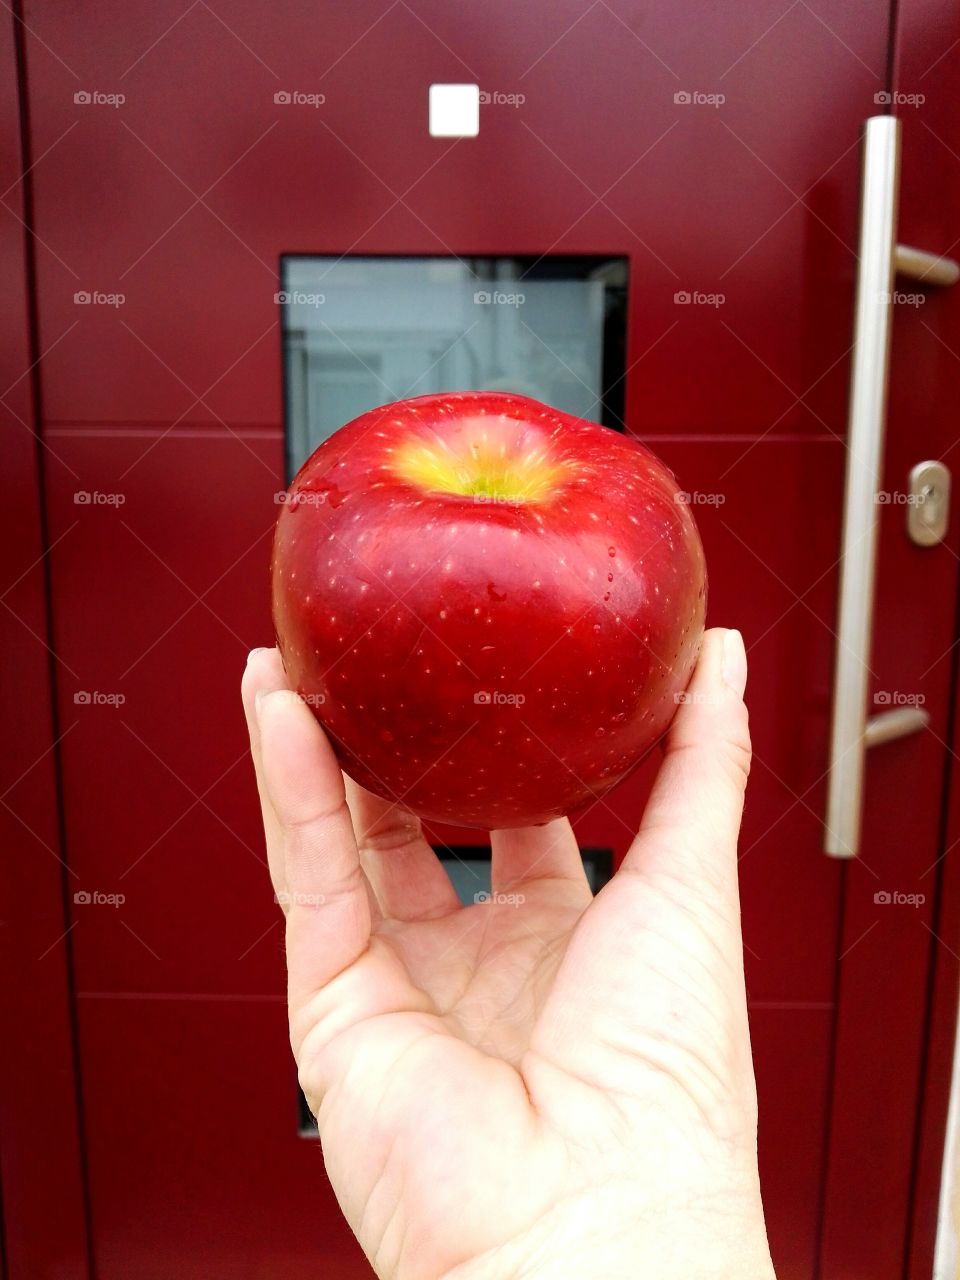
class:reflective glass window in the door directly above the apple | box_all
[282,256,627,472]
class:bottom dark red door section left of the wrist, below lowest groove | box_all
[79,996,372,1280]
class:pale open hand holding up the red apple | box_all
[243,630,773,1280]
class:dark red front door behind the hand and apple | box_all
[8,0,960,1280]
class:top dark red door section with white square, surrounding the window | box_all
[22,0,887,433]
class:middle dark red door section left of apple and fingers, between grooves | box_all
[42,426,283,995]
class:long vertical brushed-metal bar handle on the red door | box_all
[823,115,960,858]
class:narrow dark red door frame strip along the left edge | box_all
[0,12,90,1280]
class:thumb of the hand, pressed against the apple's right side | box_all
[623,628,750,911]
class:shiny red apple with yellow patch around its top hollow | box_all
[273,392,707,829]
